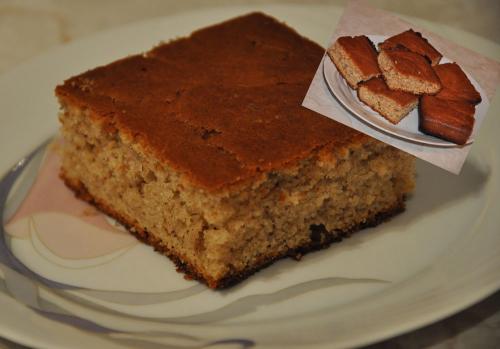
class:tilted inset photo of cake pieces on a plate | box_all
[303,10,497,174]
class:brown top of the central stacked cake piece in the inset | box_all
[383,49,441,85]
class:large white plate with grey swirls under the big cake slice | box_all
[0,5,500,348]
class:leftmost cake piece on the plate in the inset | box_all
[328,35,380,89]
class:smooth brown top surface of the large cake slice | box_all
[56,13,368,191]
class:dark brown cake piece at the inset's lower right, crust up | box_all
[419,96,475,145]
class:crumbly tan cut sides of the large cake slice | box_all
[60,104,414,288]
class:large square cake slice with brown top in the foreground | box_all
[56,13,414,288]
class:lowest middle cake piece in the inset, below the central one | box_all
[358,78,418,124]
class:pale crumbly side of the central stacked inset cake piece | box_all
[378,50,441,94]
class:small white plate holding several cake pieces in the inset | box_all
[323,35,488,147]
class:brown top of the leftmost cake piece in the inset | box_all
[337,35,380,75]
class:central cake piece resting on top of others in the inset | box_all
[378,49,441,95]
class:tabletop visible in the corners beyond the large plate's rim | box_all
[0,0,500,349]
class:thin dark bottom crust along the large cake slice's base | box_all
[59,170,405,289]
